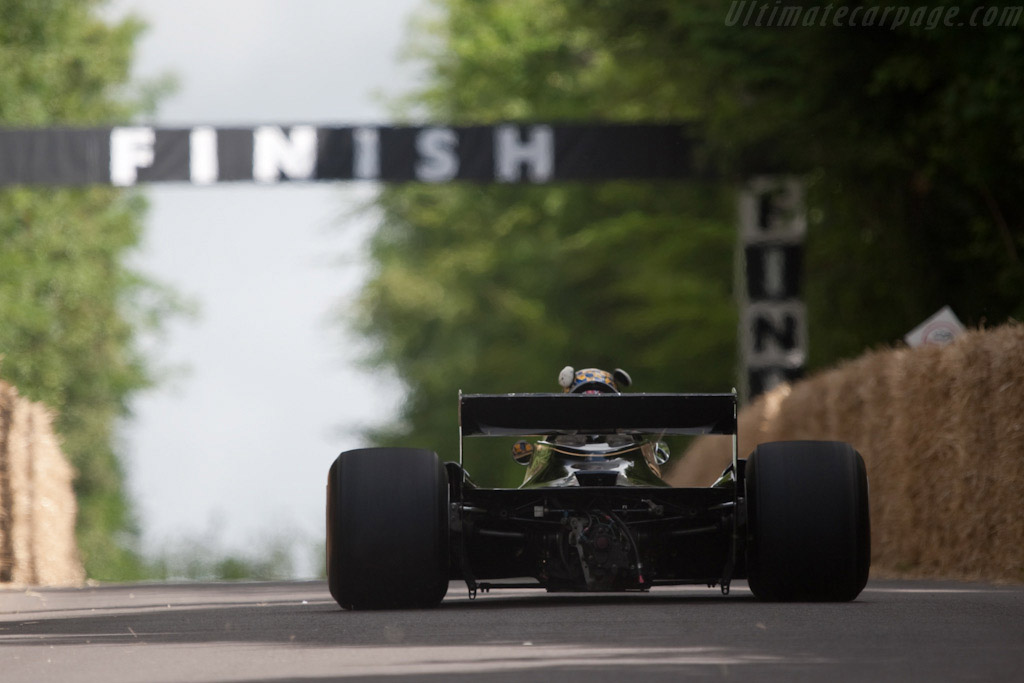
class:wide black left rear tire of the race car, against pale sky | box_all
[327,449,449,609]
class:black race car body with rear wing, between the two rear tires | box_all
[445,393,746,595]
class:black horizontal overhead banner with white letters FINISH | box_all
[0,124,706,186]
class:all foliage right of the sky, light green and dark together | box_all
[358,0,1024,481]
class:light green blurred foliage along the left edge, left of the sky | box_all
[0,0,174,580]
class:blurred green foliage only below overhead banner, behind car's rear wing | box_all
[361,183,735,481]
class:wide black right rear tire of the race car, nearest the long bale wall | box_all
[745,441,871,602]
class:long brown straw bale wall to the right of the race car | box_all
[669,324,1024,583]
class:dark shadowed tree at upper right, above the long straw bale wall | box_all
[565,0,1024,367]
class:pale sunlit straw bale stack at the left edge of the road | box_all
[0,382,85,586]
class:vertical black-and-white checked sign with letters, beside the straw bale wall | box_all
[736,176,807,400]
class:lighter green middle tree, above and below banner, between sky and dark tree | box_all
[358,0,736,483]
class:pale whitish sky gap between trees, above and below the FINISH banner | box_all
[108,0,422,575]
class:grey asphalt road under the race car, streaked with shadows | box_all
[0,582,1024,683]
